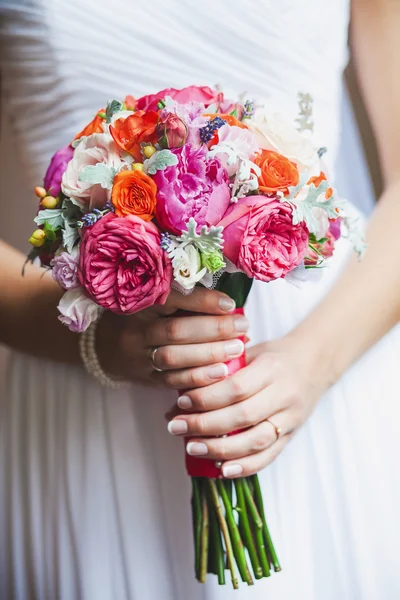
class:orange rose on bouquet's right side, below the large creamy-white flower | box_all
[254,150,299,194]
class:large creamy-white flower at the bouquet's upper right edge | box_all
[245,108,318,171]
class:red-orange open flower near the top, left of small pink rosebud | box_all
[110,110,158,161]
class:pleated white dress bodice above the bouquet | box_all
[0,0,349,184]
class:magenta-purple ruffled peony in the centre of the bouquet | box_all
[153,144,230,235]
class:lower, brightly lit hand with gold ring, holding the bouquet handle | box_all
[168,336,329,477]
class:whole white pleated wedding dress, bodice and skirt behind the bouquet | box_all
[0,0,400,600]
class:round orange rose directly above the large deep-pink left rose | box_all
[111,171,157,221]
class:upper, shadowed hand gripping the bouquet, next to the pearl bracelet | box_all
[97,288,248,389]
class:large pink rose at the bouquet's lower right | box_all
[219,196,309,282]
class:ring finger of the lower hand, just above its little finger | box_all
[186,421,277,461]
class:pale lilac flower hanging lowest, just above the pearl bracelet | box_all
[58,287,103,333]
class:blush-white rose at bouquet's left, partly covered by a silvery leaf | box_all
[61,133,124,209]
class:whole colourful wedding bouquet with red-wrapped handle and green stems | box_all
[29,86,362,588]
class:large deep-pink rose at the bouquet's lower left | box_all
[79,213,172,314]
